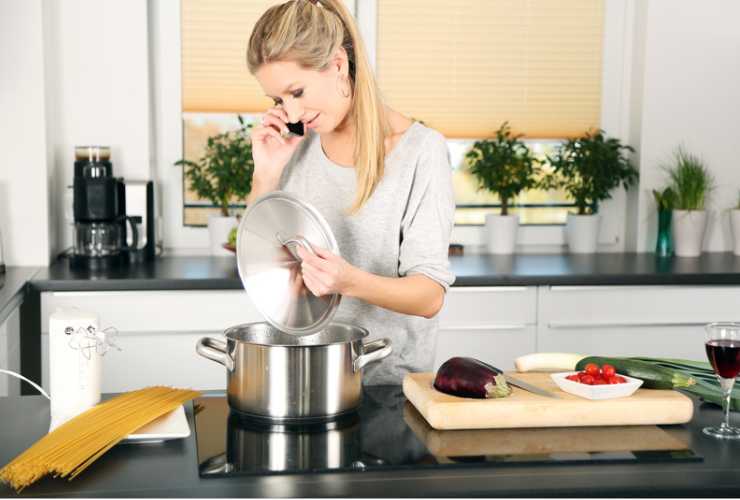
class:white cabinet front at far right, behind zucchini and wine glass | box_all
[537,286,740,361]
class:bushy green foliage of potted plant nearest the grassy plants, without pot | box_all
[544,130,638,215]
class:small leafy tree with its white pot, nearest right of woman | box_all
[465,122,540,254]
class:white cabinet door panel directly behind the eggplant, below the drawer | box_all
[434,325,537,371]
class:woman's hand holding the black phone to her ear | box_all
[250,107,305,189]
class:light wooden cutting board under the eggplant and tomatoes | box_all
[403,373,694,429]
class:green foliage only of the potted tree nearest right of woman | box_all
[465,122,540,215]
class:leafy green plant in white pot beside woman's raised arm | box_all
[175,116,254,255]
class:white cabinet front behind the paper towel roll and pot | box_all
[41,290,260,392]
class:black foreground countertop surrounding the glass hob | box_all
[0,386,740,497]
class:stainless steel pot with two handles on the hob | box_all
[196,323,391,420]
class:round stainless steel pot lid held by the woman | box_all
[236,191,341,335]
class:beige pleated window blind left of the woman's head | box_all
[181,0,281,113]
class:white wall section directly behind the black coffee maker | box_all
[44,0,152,254]
